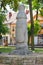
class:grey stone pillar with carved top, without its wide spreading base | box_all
[16,4,28,48]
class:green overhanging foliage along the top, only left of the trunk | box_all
[1,0,28,11]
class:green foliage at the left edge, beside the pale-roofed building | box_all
[0,12,9,35]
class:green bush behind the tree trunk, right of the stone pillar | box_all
[27,20,41,45]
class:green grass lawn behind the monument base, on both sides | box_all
[0,46,43,53]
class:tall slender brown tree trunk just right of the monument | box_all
[28,0,34,50]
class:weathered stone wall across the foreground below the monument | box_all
[0,54,43,65]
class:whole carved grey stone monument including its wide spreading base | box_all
[11,4,31,55]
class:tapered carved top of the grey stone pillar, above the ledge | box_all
[16,4,27,19]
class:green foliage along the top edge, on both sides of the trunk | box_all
[1,0,43,11]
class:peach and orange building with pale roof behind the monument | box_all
[3,10,43,45]
